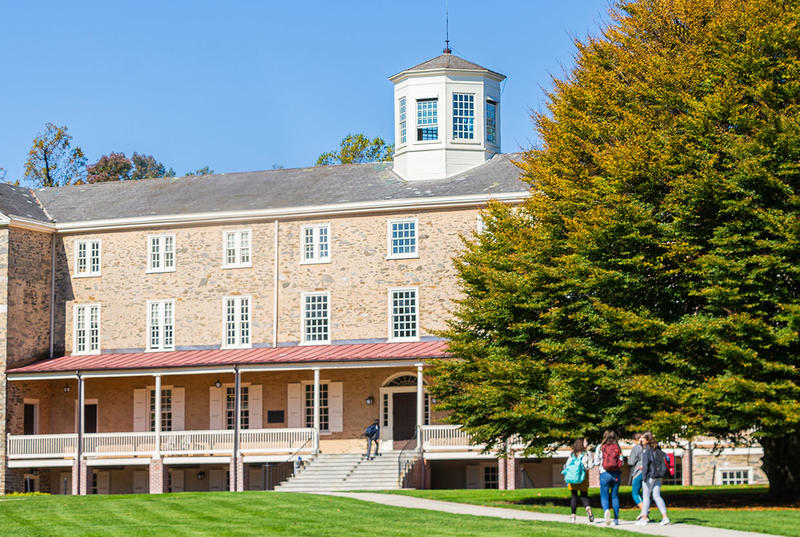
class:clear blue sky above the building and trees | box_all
[0,0,609,183]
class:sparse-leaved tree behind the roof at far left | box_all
[25,123,86,187]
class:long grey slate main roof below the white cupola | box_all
[34,153,528,223]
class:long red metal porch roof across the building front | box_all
[6,341,448,374]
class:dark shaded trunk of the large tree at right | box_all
[759,433,800,503]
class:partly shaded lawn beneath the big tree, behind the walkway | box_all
[391,486,800,537]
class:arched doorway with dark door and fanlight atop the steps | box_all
[380,372,429,450]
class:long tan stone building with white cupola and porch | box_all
[0,53,763,494]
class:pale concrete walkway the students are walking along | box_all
[324,492,775,537]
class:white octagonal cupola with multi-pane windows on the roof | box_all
[389,49,506,181]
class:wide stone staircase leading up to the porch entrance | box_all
[275,451,416,492]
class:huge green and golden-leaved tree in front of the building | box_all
[432,0,800,500]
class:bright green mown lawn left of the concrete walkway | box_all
[0,492,603,537]
